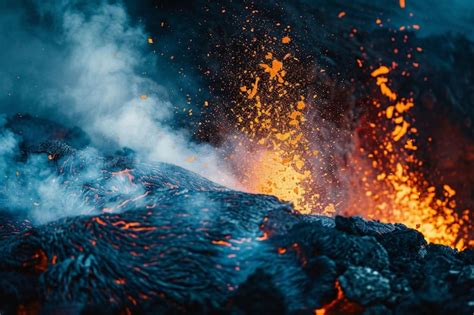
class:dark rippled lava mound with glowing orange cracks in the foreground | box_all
[0,115,474,314]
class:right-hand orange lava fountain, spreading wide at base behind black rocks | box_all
[347,66,472,249]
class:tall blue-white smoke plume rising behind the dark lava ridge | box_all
[0,1,237,185]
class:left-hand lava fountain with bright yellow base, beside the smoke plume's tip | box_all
[231,47,317,213]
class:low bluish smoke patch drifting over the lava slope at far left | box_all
[0,116,154,223]
